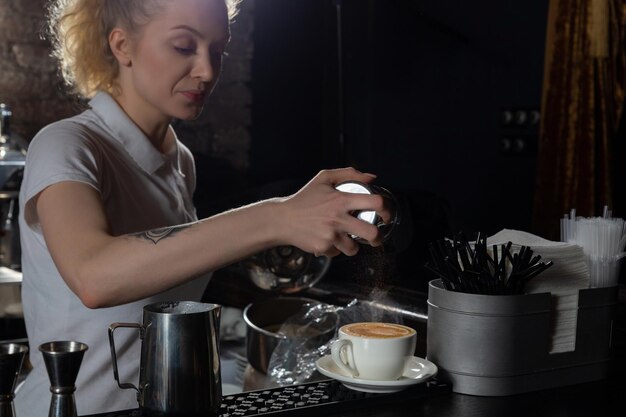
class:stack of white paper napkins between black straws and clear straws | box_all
[487,229,589,353]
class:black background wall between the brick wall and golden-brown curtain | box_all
[200,0,544,290]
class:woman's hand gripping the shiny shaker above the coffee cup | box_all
[276,168,391,257]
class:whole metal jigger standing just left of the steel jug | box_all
[39,341,88,417]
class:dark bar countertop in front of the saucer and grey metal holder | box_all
[84,375,626,417]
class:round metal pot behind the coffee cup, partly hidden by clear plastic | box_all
[243,297,338,374]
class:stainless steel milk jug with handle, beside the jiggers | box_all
[109,301,222,415]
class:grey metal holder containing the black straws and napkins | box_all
[427,279,618,396]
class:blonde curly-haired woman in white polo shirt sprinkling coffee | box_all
[16,0,389,417]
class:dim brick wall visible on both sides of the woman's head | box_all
[0,0,254,172]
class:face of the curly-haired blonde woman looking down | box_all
[121,0,230,120]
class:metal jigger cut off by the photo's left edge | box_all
[0,343,28,417]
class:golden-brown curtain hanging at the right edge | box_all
[533,0,626,240]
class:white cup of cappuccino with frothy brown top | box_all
[331,322,417,381]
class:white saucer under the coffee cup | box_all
[315,355,437,393]
